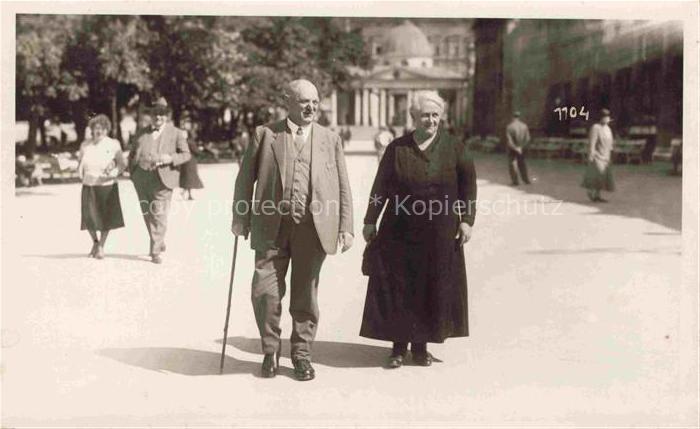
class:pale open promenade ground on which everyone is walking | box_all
[2,150,698,427]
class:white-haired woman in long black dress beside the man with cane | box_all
[360,91,477,368]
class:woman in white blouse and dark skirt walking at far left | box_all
[78,115,126,259]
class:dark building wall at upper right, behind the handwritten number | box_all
[473,20,683,145]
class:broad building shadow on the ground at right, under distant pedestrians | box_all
[474,153,683,231]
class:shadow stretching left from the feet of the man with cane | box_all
[97,347,260,376]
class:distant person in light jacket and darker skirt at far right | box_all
[581,109,615,203]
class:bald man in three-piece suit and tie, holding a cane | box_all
[231,79,353,381]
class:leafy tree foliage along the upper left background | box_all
[16,15,368,150]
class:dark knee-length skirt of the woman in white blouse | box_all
[80,183,124,231]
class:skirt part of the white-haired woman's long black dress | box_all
[360,216,469,343]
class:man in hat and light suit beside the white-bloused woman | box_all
[129,97,191,264]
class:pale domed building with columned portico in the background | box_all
[329,18,473,128]
